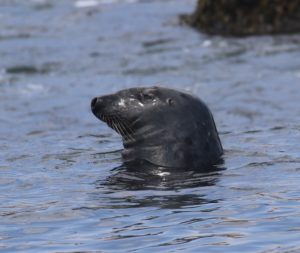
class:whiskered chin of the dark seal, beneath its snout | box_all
[95,114,133,139]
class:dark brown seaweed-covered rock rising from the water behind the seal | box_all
[181,0,300,36]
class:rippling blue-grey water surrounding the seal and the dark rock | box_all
[0,0,300,253]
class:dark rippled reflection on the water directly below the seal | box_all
[92,163,224,209]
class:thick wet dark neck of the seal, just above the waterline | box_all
[122,117,223,168]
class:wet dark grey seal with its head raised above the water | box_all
[91,87,223,170]
